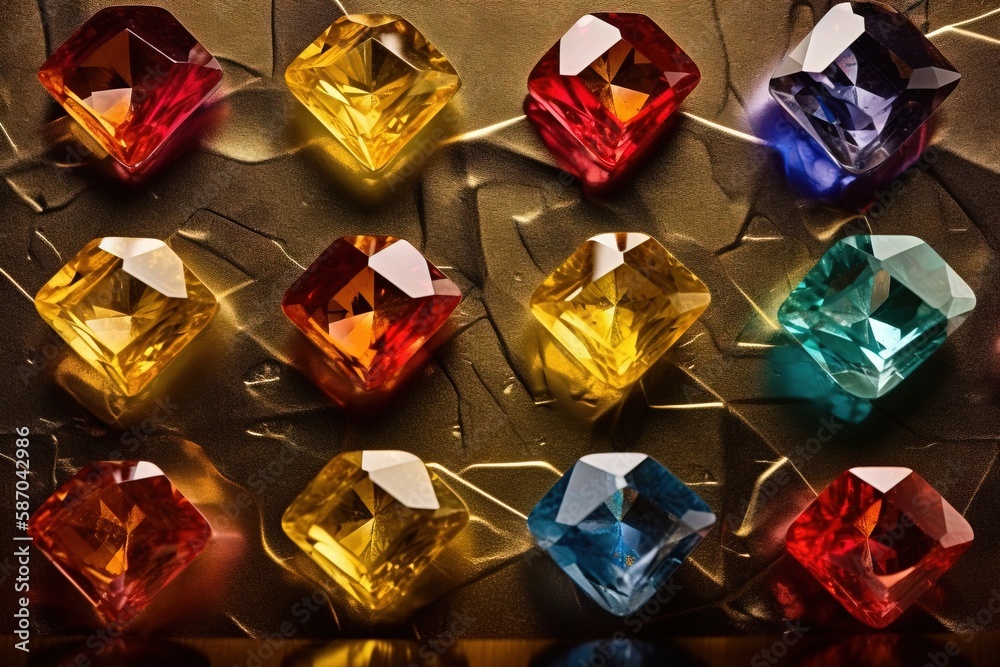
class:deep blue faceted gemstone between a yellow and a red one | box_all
[528,453,715,616]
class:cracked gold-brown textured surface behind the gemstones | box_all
[0,0,1000,639]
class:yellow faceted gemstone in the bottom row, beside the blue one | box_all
[281,451,469,610]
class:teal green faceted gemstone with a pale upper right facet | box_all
[778,235,976,398]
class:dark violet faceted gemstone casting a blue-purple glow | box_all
[770,2,960,173]
